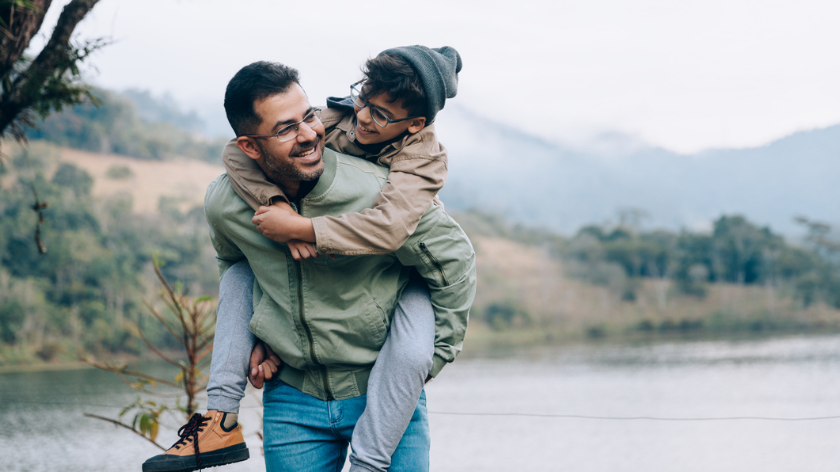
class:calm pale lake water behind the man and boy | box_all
[0,336,840,472]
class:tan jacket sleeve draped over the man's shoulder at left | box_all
[222,139,289,211]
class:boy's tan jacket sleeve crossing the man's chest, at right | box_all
[312,143,447,255]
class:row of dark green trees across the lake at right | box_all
[562,215,840,308]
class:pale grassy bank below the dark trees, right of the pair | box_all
[470,237,840,345]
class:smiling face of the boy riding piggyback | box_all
[353,93,426,144]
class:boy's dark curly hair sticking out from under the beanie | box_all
[362,53,426,116]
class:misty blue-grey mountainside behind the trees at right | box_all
[437,107,840,233]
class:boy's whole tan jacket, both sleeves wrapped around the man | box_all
[222,108,447,255]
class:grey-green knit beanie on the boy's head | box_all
[379,46,461,124]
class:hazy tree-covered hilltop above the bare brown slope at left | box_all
[27,89,224,162]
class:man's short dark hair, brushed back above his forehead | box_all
[225,61,300,136]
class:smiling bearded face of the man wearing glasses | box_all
[249,84,324,187]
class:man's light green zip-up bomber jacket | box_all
[204,148,476,400]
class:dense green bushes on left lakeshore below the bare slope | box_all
[0,146,218,364]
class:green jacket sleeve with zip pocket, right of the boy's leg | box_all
[395,205,476,377]
